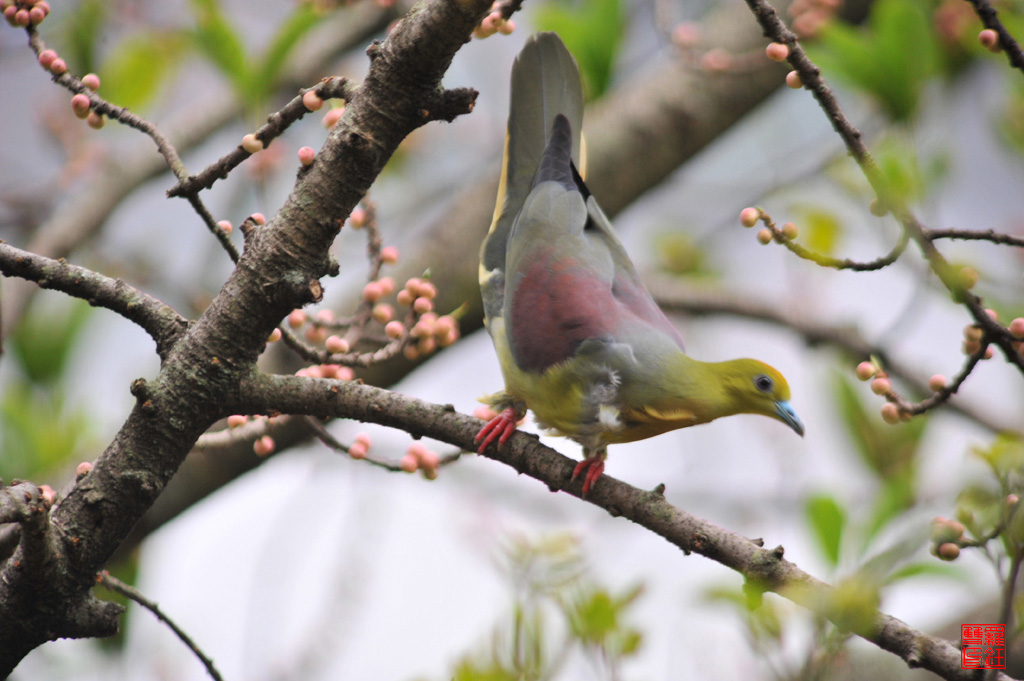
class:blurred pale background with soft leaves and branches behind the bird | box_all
[0,0,1024,681]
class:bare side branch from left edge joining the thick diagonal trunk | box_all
[0,241,188,359]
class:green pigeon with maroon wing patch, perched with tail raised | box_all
[475,32,804,497]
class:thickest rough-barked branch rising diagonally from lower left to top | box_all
[0,0,489,676]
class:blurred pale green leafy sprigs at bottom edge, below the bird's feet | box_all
[436,534,643,681]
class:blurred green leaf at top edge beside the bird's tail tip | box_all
[534,0,625,99]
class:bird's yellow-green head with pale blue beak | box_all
[715,359,804,435]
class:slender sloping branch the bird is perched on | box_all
[240,375,991,681]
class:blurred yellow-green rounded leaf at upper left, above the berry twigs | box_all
[100,31,185,110]
